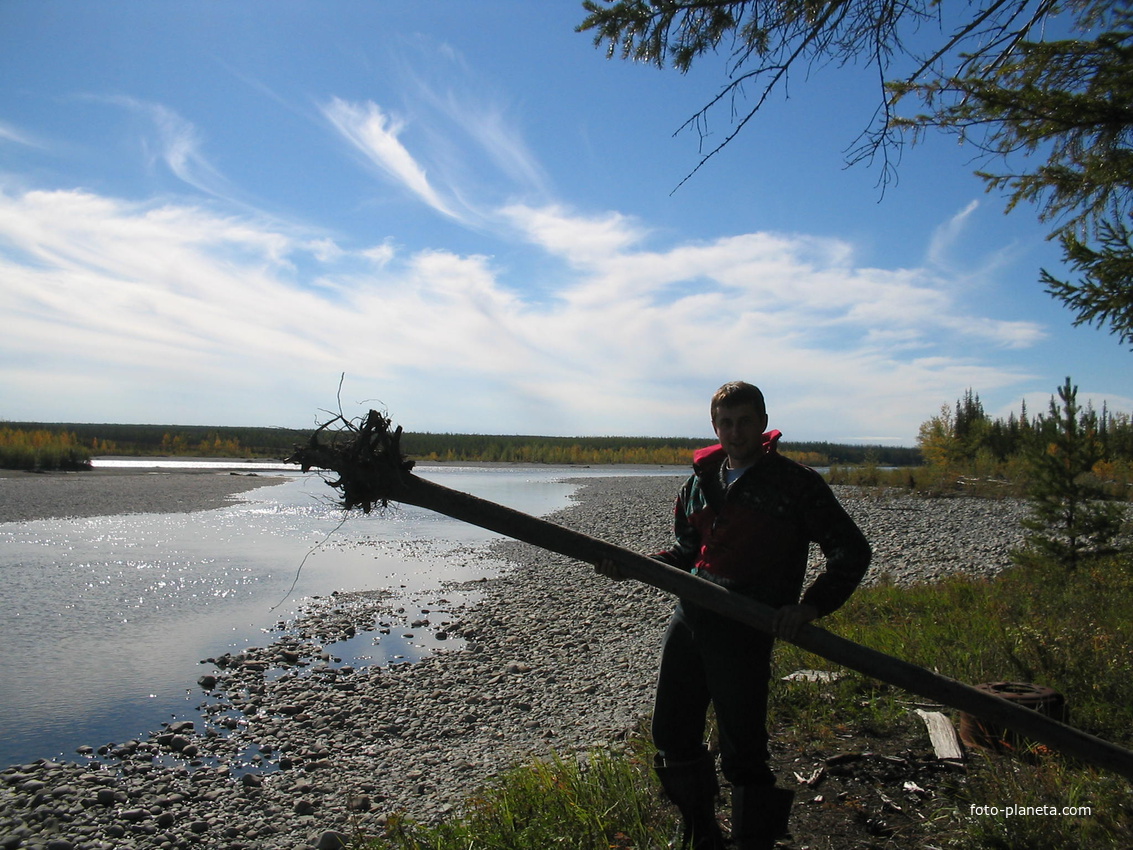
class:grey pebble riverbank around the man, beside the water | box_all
[0,477,1023,850]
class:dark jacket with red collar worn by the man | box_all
[655,431,871,615]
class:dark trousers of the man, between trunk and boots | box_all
[653,601,775,785]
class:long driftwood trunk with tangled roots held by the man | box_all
[289,410,1133,781]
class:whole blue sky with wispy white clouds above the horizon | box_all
[0,0,1133,444]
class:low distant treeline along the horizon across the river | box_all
[0,422,921,466]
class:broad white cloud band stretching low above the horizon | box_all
[0,185,1040,440]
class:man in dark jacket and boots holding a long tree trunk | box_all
[598,381,870,850]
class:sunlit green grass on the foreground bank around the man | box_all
[357,555,1133,850]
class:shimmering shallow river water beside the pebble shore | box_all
[0,467,664,766]
